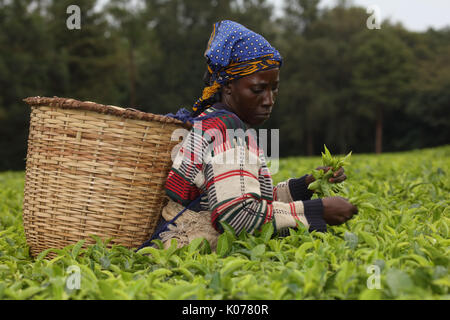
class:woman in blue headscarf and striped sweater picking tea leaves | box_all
[156,20,357,248]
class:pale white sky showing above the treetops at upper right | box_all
[269,0,450,32]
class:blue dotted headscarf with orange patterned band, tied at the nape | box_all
[192,20,282,112]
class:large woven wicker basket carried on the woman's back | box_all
[23,97,190,256]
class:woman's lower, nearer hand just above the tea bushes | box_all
[322,197,358,226]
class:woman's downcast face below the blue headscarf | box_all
[222,68,280,126]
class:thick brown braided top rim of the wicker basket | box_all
[23,96,192,129]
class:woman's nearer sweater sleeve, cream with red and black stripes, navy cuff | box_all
[203,115,326,234]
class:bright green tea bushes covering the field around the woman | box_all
[0,146,450,300]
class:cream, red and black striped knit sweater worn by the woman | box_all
[165,103,326,235]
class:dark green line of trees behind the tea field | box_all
[0,0,450,171]
